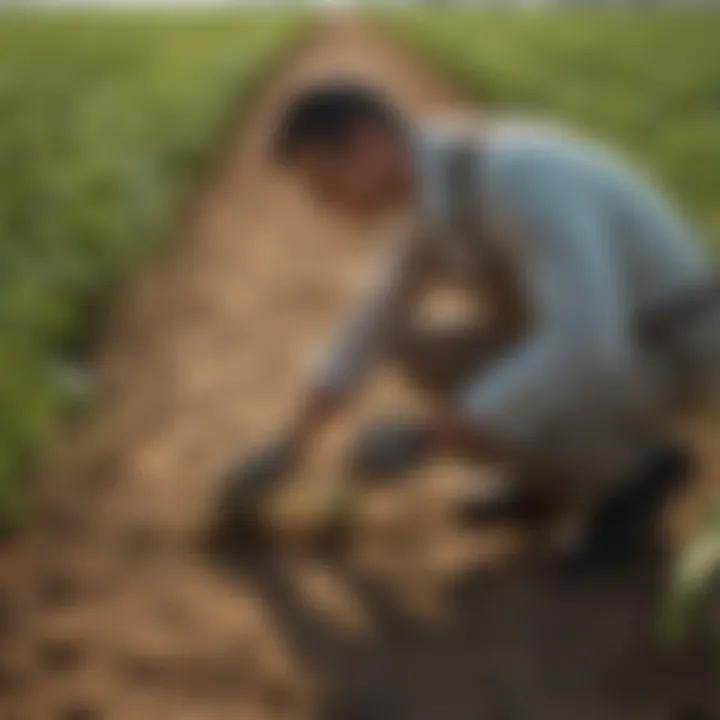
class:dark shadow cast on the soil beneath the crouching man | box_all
[210,536,720,720]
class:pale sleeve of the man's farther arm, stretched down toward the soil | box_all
[312,231,429,394]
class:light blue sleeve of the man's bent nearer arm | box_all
[457,160,631,447]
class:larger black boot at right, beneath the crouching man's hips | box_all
[563,445,694,570]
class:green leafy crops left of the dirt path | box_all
[0,12,302,518]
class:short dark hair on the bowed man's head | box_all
[273,82,405,161]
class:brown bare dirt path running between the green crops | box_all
[0,16,720,720]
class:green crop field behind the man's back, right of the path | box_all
[389,10,720,246]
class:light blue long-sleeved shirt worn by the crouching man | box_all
[316,123,711,450]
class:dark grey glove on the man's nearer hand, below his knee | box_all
[349,417,430,480]
